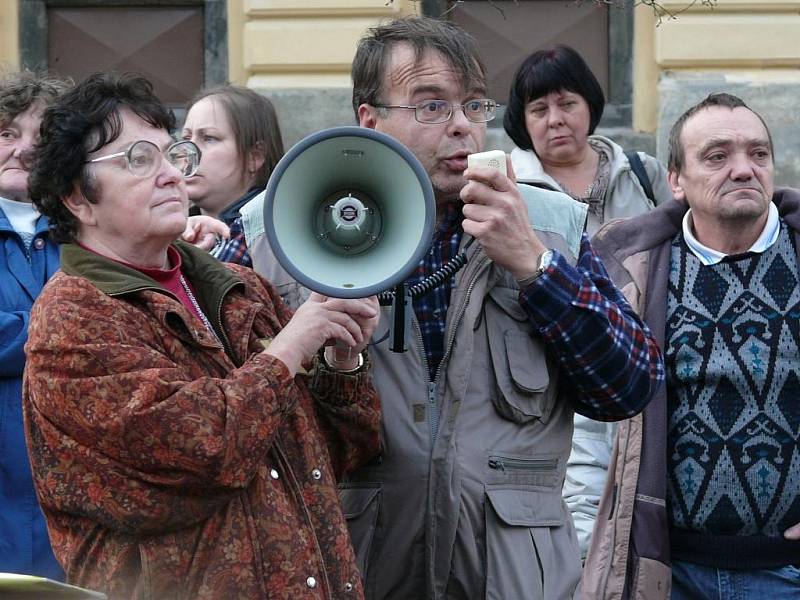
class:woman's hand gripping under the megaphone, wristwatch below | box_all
[264,293,380,374]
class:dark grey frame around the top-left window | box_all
[19,0,228,87]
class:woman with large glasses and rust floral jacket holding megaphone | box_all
[23,73,380,600]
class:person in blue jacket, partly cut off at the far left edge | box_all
[0,71,68,579]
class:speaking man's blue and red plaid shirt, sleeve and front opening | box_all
[408,203,664,420]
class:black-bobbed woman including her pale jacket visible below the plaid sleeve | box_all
[503,46,672,557]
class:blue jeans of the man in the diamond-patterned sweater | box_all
[672,561,800,600]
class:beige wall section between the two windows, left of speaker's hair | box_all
[228,0,417,89]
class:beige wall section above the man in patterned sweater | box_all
[633,0,800,132]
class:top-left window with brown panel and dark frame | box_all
[20,0,227,108]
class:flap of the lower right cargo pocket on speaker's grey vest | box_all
[486,486,565,527]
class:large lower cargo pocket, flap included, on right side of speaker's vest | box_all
[486,485,580,600]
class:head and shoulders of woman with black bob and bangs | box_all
[503,46,672,235]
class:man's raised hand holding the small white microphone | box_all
[461,156,547,279]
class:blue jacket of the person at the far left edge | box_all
[0,209,64,579]
